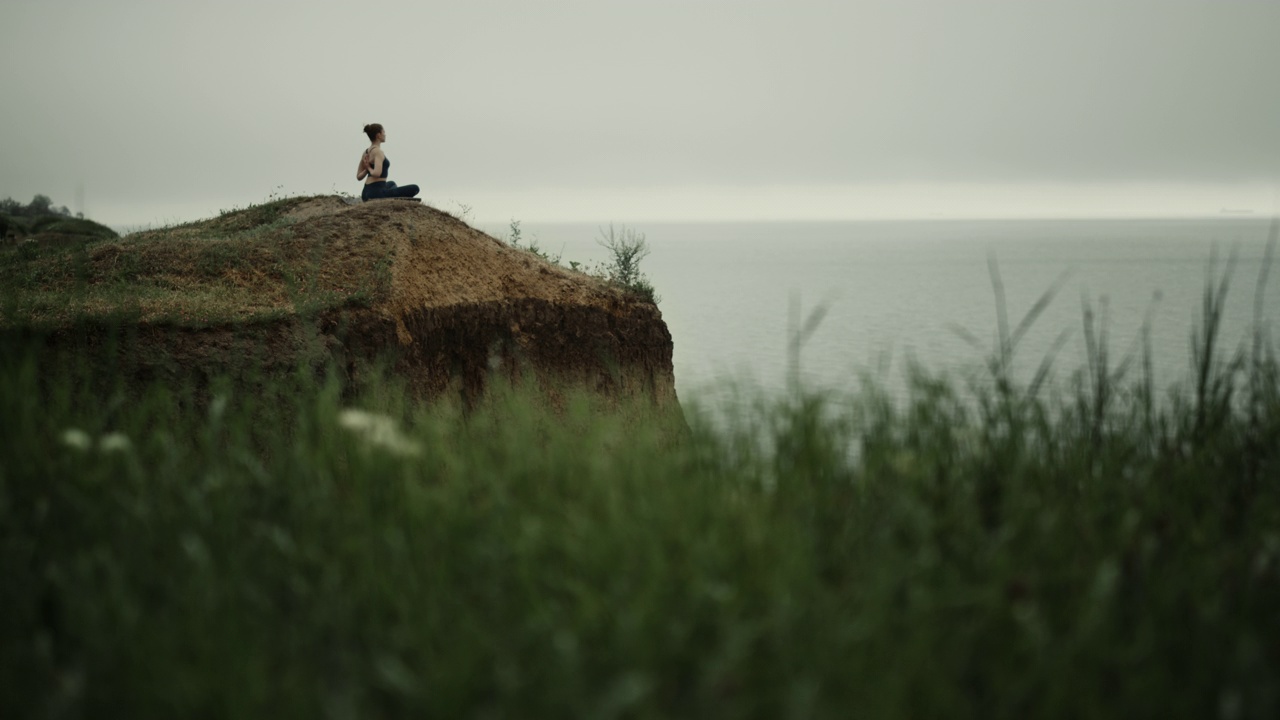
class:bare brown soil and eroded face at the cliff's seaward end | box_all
[339,201,676,405]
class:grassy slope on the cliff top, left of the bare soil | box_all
[0,197,389,328]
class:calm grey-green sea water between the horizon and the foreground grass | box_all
[514,219,1280,398]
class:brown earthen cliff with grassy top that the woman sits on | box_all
[5,197,678,409]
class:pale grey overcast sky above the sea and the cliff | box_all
[0,0,1280,224]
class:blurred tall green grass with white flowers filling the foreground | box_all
[0,278,1280,719]
